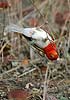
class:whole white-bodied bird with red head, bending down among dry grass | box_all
[4,24,58,61]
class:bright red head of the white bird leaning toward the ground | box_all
[43,43,58,60]
